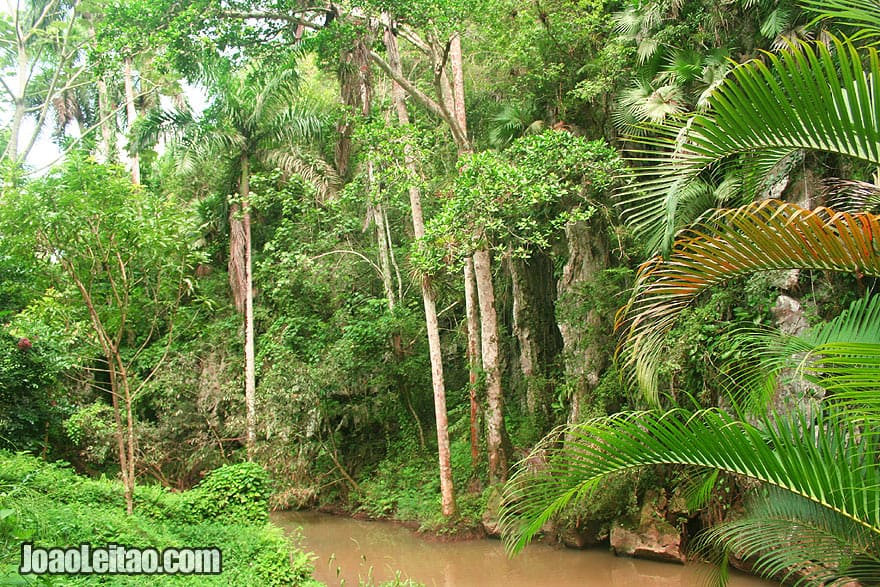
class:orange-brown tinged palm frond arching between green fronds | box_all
[616,200,880,401]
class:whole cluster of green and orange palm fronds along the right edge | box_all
[502,0,880,585]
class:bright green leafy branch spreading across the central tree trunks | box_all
[413,131,621,274]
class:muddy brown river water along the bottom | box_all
[272,512,772,587]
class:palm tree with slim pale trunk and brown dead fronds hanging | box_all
[133,54,339,458]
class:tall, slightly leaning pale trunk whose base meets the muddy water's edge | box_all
[385,27,456,516]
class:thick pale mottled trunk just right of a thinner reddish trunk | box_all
[473,247,507,484]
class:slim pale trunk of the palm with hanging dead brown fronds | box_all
[239,155,257,460]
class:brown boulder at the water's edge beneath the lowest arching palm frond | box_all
[611,495,686,563]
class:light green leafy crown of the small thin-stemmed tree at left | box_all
[0,154,194,360]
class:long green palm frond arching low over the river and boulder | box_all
[501,409,880,564]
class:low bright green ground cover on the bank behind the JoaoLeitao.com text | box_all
[0,453,317,587]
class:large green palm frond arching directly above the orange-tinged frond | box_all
[618,39,880,255]
